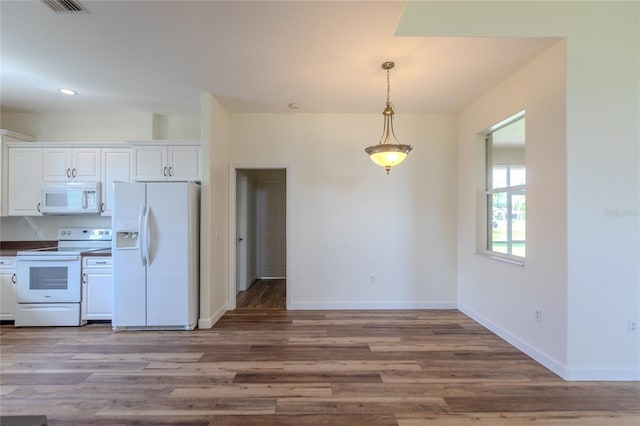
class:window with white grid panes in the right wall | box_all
[485,111,527,258]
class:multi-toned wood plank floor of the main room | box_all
[0,309,640,426]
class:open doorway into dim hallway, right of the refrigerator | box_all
[232,168,287,309]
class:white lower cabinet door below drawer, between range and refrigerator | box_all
[81,269,113,320]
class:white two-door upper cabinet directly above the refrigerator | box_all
[130,141,201,181]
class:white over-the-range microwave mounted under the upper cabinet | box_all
[40,182,101,214]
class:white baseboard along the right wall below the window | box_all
[458,305,640,381]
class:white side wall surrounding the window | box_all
[458,42,567,373]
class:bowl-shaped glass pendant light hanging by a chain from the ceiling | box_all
[365,61,412,174]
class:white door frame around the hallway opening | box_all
[227,164,293,310]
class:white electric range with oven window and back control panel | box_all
[15,228,111,327]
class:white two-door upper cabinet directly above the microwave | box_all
[44,147,100,182]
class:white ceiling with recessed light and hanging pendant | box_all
[0,0,554,114]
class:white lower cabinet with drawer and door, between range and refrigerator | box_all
[80,256,113,321]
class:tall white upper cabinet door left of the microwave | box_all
[9,148,42,216]
